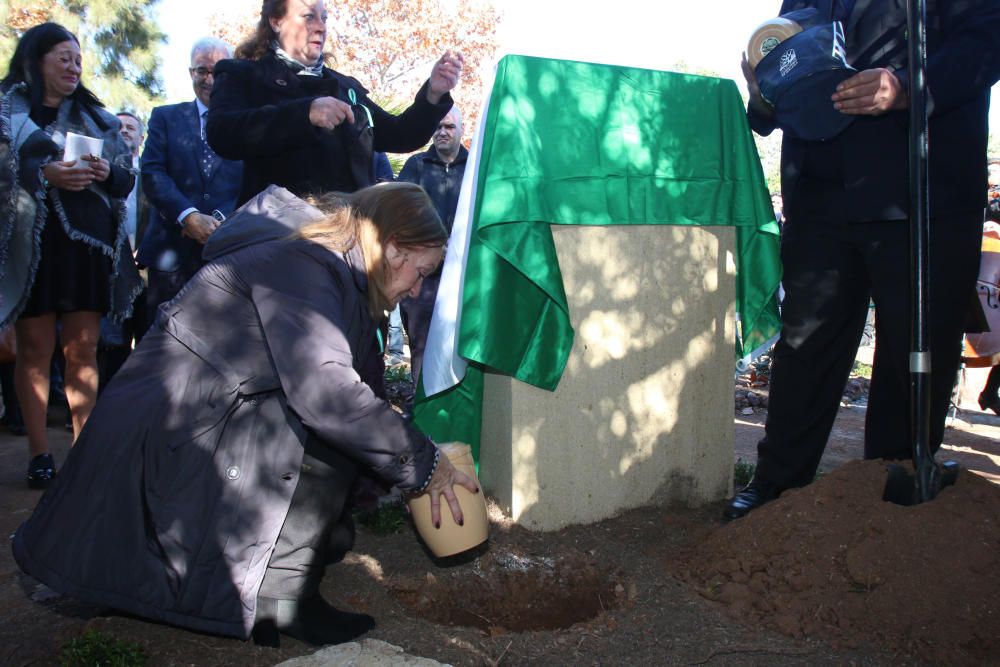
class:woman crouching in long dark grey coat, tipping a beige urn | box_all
[13,183,478,644]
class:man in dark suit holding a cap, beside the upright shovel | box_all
[724,0,1000,519]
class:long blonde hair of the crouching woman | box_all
[294,183,448,319]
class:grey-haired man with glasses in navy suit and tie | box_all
[136,38,243,323]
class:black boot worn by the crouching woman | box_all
[251,595,375,646]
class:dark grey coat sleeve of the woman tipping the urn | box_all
[251,245,435,491]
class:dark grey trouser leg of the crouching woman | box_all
[257,437,358,600]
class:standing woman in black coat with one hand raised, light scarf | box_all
[207,0,462,203]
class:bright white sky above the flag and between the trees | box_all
[152,0,1000,128]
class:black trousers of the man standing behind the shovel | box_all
[757,215,982,488]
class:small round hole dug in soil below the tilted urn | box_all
[392,551,625,634]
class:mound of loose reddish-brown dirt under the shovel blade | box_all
[679,461,1000,664]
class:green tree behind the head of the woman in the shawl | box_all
[0,0,165,117]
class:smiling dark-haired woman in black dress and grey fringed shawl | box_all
[0,23,141,488]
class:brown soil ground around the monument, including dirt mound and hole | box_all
[0,378,1000,667]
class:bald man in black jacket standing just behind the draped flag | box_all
[396,106,469,382]
